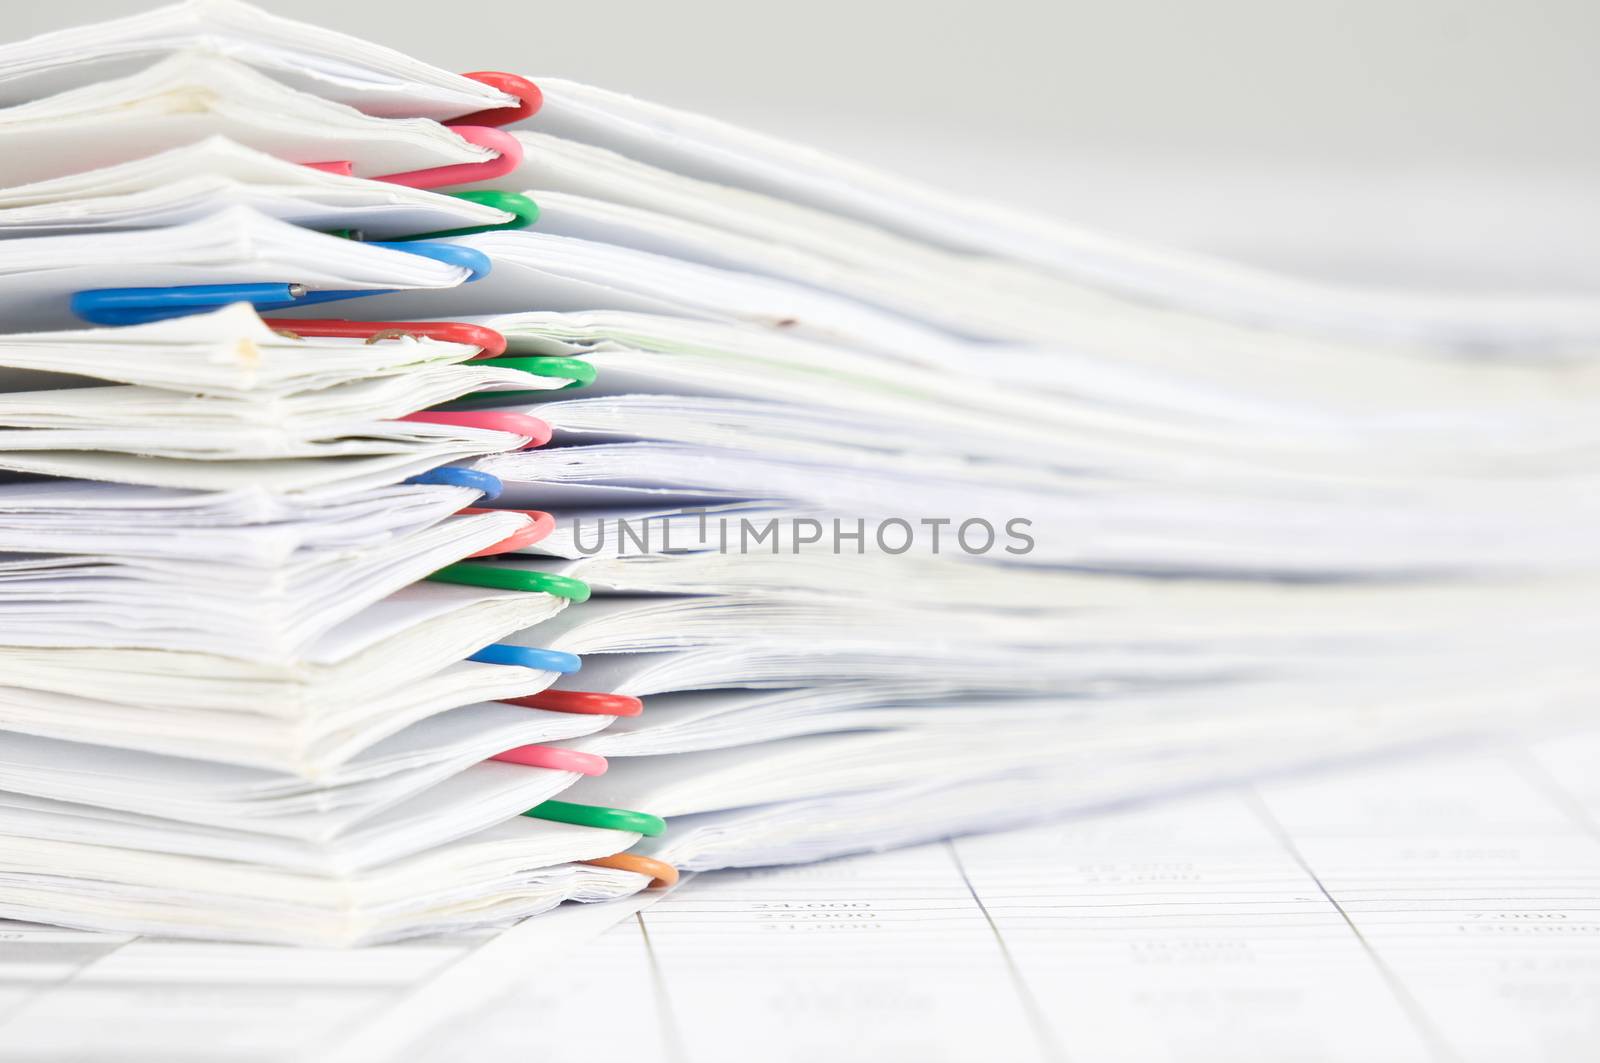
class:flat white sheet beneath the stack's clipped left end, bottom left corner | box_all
[0,893,658,1063]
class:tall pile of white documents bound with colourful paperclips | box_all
[0,0,1600,945]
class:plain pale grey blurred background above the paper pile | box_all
[6,0,1600,291]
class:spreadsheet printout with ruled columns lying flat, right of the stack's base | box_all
[410,736,1600,1063]
